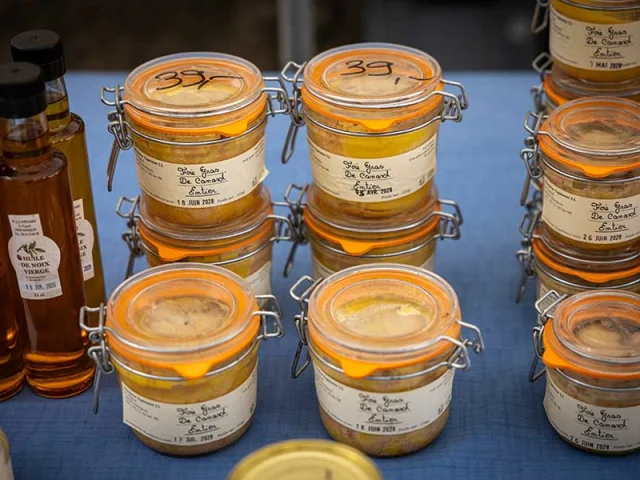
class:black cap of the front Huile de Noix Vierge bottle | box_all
[0,62,47,118]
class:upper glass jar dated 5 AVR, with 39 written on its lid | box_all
[283,43,467,218]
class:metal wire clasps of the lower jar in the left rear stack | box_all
[116,196,295,280]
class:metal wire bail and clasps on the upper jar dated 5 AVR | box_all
[280,62,469,163]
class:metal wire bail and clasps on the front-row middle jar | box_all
[289,275,484,381]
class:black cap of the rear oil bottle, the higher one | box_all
[11,30,67,82]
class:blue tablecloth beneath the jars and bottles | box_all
[0,73,640,480]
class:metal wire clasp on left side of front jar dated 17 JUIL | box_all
[79,303,114,413]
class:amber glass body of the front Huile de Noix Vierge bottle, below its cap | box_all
[0,112,94,397]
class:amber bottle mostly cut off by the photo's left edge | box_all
[0,222,24,401]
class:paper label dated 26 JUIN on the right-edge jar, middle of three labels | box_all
[542,177,640,244]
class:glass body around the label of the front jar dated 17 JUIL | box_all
[114,342,259,456]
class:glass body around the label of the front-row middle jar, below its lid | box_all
[310,343,453,457]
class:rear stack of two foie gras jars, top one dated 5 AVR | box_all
[282,43,468,278]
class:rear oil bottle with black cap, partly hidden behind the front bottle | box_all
[11,30,105,305]
